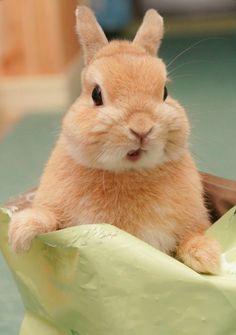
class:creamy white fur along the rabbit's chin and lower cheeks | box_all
[61,137,185,172]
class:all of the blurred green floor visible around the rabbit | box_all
[0,34,236,335]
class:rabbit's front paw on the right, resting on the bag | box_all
[177,235,221,274]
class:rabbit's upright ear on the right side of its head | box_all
[133,9,163,56]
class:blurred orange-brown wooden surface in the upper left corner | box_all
[0,0,79,76]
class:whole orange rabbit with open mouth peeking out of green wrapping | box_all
[9,6,221,274]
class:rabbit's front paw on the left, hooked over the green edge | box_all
[8,208,56,253]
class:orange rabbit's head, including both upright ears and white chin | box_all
[62,7,189,172]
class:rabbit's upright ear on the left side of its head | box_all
[75,6,108,64]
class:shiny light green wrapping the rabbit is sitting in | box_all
[0,208,236,335]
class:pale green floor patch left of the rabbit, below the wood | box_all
[0,112,62,204]
